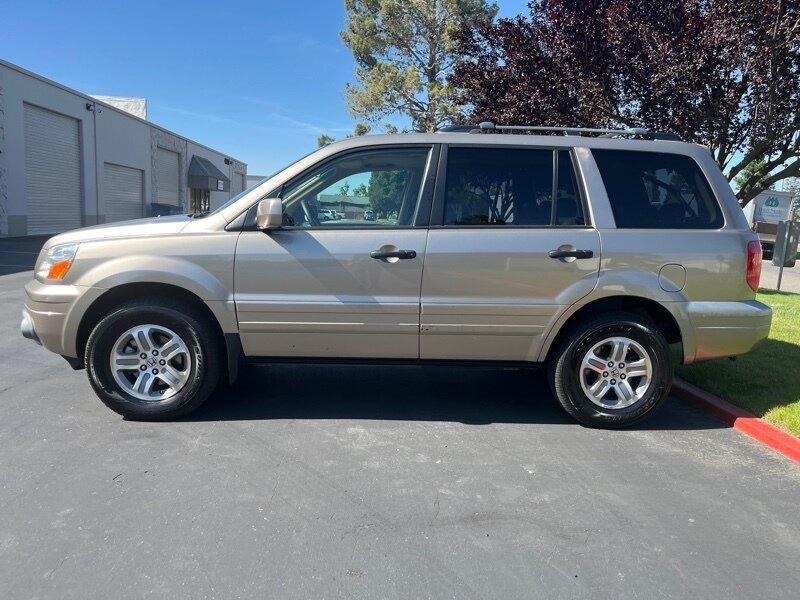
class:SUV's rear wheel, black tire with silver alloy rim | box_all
[548,313,672,429]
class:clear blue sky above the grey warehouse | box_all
[0,0,527,174]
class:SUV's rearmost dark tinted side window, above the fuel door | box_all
[592,150,724,229]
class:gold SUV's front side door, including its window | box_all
[235,146,435,358]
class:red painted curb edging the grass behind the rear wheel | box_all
[672,379,800,463]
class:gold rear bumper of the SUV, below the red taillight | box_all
[687,300,772,360]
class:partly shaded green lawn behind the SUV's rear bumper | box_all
[676,290,800,437]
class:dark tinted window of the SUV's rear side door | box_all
[444,147,584,227]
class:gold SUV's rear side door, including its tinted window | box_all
[420,145,600,361]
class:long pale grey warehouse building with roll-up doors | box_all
[0,60,247,236]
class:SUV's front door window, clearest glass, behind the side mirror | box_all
[282,148,430,228]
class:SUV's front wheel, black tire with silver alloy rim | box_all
[84,298,224,421]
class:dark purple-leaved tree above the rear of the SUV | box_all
[450,0,800,206]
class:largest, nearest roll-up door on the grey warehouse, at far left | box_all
[24,104,83,235]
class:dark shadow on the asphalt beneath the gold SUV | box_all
[183,364,726,430]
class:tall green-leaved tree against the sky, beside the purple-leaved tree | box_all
[341,0,497,132]
